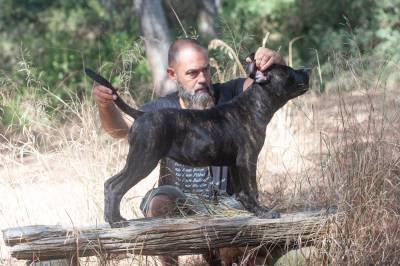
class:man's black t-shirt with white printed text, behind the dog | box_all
[140,78,245,197]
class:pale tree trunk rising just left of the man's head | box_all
[134,0,176,96]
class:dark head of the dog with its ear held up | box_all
[247,59,309,101]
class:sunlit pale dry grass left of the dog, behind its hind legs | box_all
[0,51,157,265]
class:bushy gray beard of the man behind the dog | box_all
[178,84,215,110]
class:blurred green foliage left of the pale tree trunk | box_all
[0,0,150,128]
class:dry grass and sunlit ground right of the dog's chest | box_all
[255,54,400,265]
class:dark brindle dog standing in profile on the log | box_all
[87,63,308,226]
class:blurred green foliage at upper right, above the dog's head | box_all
[220,0,400,93]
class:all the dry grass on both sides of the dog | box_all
[0,44,400,265]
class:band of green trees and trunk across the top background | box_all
[0,0,400,124]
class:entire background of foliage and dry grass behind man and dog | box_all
[0,0,400,265]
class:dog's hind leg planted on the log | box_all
[104,141,160,226]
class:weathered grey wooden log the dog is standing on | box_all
[3,212,337,260]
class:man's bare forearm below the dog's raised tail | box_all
[99,105,129,138]
